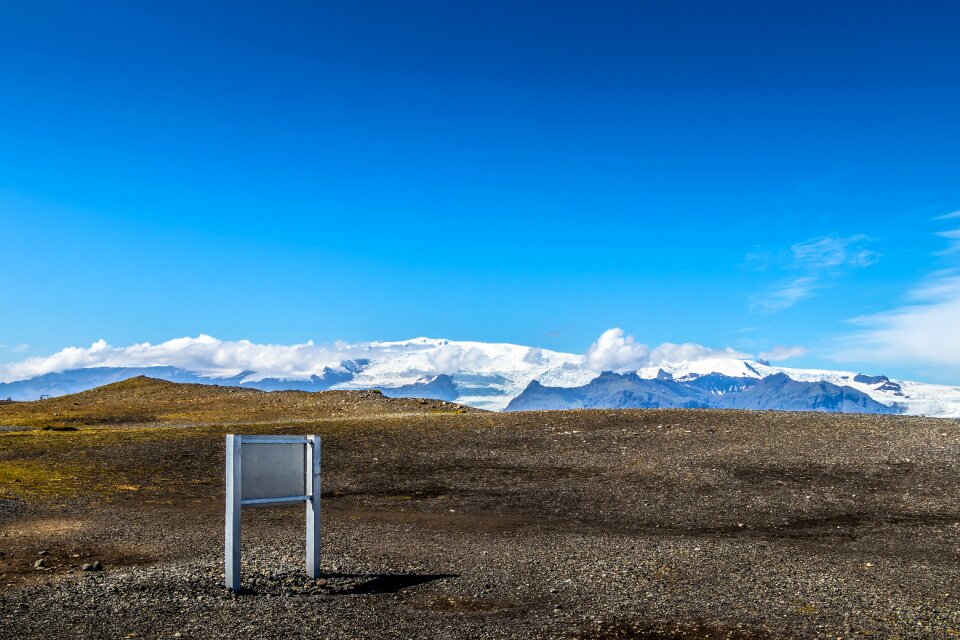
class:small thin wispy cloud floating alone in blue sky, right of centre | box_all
[744,234,880,313]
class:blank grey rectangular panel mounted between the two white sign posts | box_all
[240,442,307,500]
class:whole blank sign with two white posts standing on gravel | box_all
[223,434,320,591]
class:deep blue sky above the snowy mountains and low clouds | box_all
[0,1,960,384]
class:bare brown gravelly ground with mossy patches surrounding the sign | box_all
[0,378,960,639]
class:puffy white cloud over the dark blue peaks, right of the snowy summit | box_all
[584,327,749,371]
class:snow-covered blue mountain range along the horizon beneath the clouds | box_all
[0,338,960,417]
